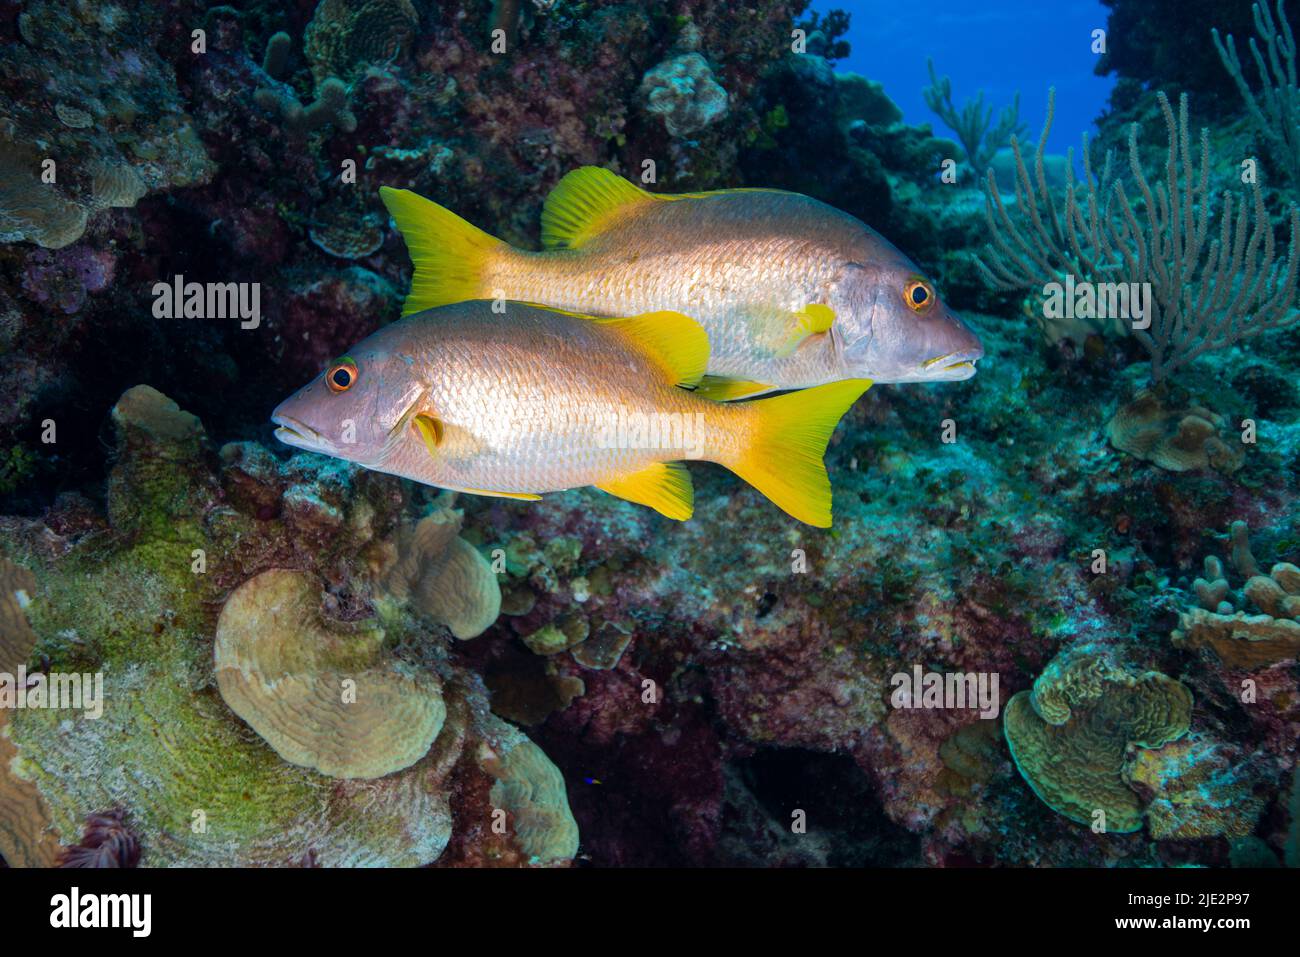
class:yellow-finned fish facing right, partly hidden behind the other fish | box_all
[380,166,984,399]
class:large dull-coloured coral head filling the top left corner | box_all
[0,0,215,248]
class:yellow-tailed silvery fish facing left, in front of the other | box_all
[272,300,871,528]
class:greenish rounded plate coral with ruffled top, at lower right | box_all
[1004,645,1192,832]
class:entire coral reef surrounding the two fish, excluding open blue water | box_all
[0,0,1300,867]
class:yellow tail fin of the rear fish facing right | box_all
[380,186,507,316]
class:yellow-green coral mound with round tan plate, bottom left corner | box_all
[0,389,576,866]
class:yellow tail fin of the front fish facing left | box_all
[722,378,871,528]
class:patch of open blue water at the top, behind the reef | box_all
[811,0,1114,153]
